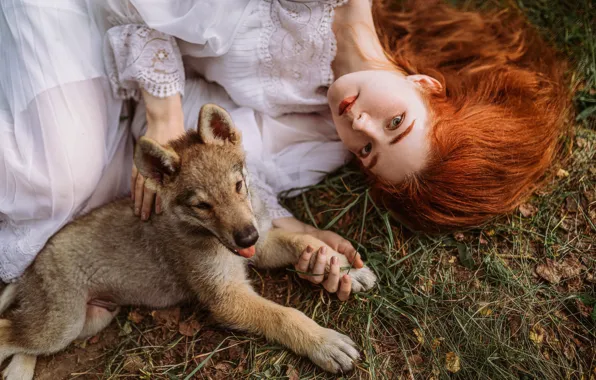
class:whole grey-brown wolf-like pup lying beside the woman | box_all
[0,105,376,380]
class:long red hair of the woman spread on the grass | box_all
[373,1,571,231]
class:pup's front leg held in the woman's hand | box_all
[251,229,377,292]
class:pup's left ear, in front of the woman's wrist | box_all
[134,136,180,184]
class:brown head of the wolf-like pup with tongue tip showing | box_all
[135,104,259,257]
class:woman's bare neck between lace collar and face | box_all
[331,0,395,80]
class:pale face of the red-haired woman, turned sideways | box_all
[327,70,441,182]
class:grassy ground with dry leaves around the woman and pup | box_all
[26,0,596,380]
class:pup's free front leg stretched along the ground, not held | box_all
[209,283,360,373]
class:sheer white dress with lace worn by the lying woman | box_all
[0,0,349,281]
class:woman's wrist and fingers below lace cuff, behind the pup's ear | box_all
[130,90,184,220]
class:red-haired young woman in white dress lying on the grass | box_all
[0,0,569,299]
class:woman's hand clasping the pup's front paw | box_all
[273,218,364,301]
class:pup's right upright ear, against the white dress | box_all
[197,104,240,144]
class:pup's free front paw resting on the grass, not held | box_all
[308,328,360,373]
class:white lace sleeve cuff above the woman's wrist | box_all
[104,24,184,100]
